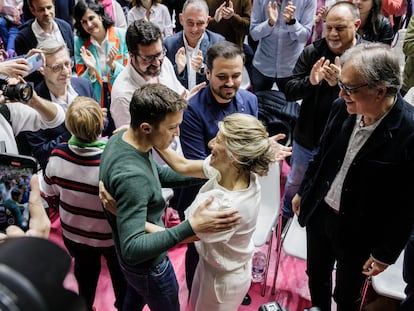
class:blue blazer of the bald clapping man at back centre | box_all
[163,29,225,89]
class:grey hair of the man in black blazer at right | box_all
[341,43,402,96]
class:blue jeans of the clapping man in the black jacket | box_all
[282,140,318,218]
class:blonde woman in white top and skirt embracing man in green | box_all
[160,113,280,311]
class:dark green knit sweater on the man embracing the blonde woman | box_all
[100,131,201,267]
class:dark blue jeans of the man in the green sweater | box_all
[121,257,180,311]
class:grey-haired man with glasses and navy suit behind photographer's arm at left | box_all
[24,39,98,173]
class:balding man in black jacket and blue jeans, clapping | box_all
[282,1,363,228]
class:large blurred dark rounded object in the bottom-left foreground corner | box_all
[0,236,87,311]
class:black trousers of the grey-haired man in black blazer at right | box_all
[306,203,370,311]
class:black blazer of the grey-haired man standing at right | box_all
[298,95,414,264]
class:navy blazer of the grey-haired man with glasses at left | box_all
[25,77,96,168]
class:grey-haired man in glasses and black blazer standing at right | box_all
[292,43,414,311]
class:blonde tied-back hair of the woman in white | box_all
[218,113,275,176]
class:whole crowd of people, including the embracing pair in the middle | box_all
[0,0,414,311]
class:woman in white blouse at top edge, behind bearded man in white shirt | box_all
[127,0,173,38]
